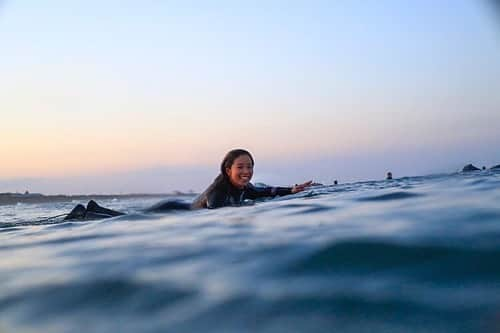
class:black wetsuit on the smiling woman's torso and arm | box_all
[191,176,292,209]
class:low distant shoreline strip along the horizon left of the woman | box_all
[0,192,195,206]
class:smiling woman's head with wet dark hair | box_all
[220,149,254,188]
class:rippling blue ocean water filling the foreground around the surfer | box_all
[0,171,500,333]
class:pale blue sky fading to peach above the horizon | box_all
[0,0,500,194]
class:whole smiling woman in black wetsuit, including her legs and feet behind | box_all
[65,149,312,220]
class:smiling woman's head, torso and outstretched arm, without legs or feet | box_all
[192,149,312,208]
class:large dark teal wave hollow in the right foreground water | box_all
[284,240,500,283]
